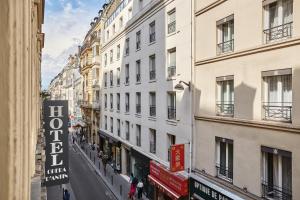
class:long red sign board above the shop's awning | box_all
[150,161,188,196]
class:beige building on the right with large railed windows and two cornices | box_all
[190,0,300,199]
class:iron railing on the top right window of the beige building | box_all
[263,22,293,43]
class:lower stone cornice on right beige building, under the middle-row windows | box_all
[195,116,300,134]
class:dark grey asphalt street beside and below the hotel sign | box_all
[47,138,116,200]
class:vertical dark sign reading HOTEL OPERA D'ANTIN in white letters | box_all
[43,100,69,186]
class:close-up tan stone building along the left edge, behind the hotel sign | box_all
[0,0,44,200]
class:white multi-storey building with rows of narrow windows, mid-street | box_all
[99,0,192,199]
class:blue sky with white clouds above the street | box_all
[42,0,105,89]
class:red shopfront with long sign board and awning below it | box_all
[148,160,188,200]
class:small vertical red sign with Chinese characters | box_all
[170,144,184,172]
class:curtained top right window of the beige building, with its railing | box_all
[264,0,293,43]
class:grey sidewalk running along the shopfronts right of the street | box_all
[75,139,147,200]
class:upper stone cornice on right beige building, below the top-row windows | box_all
[195,37,300,66]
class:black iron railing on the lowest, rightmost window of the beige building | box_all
[262,181,292,200]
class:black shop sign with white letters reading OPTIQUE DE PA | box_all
[190,177,233,200]
